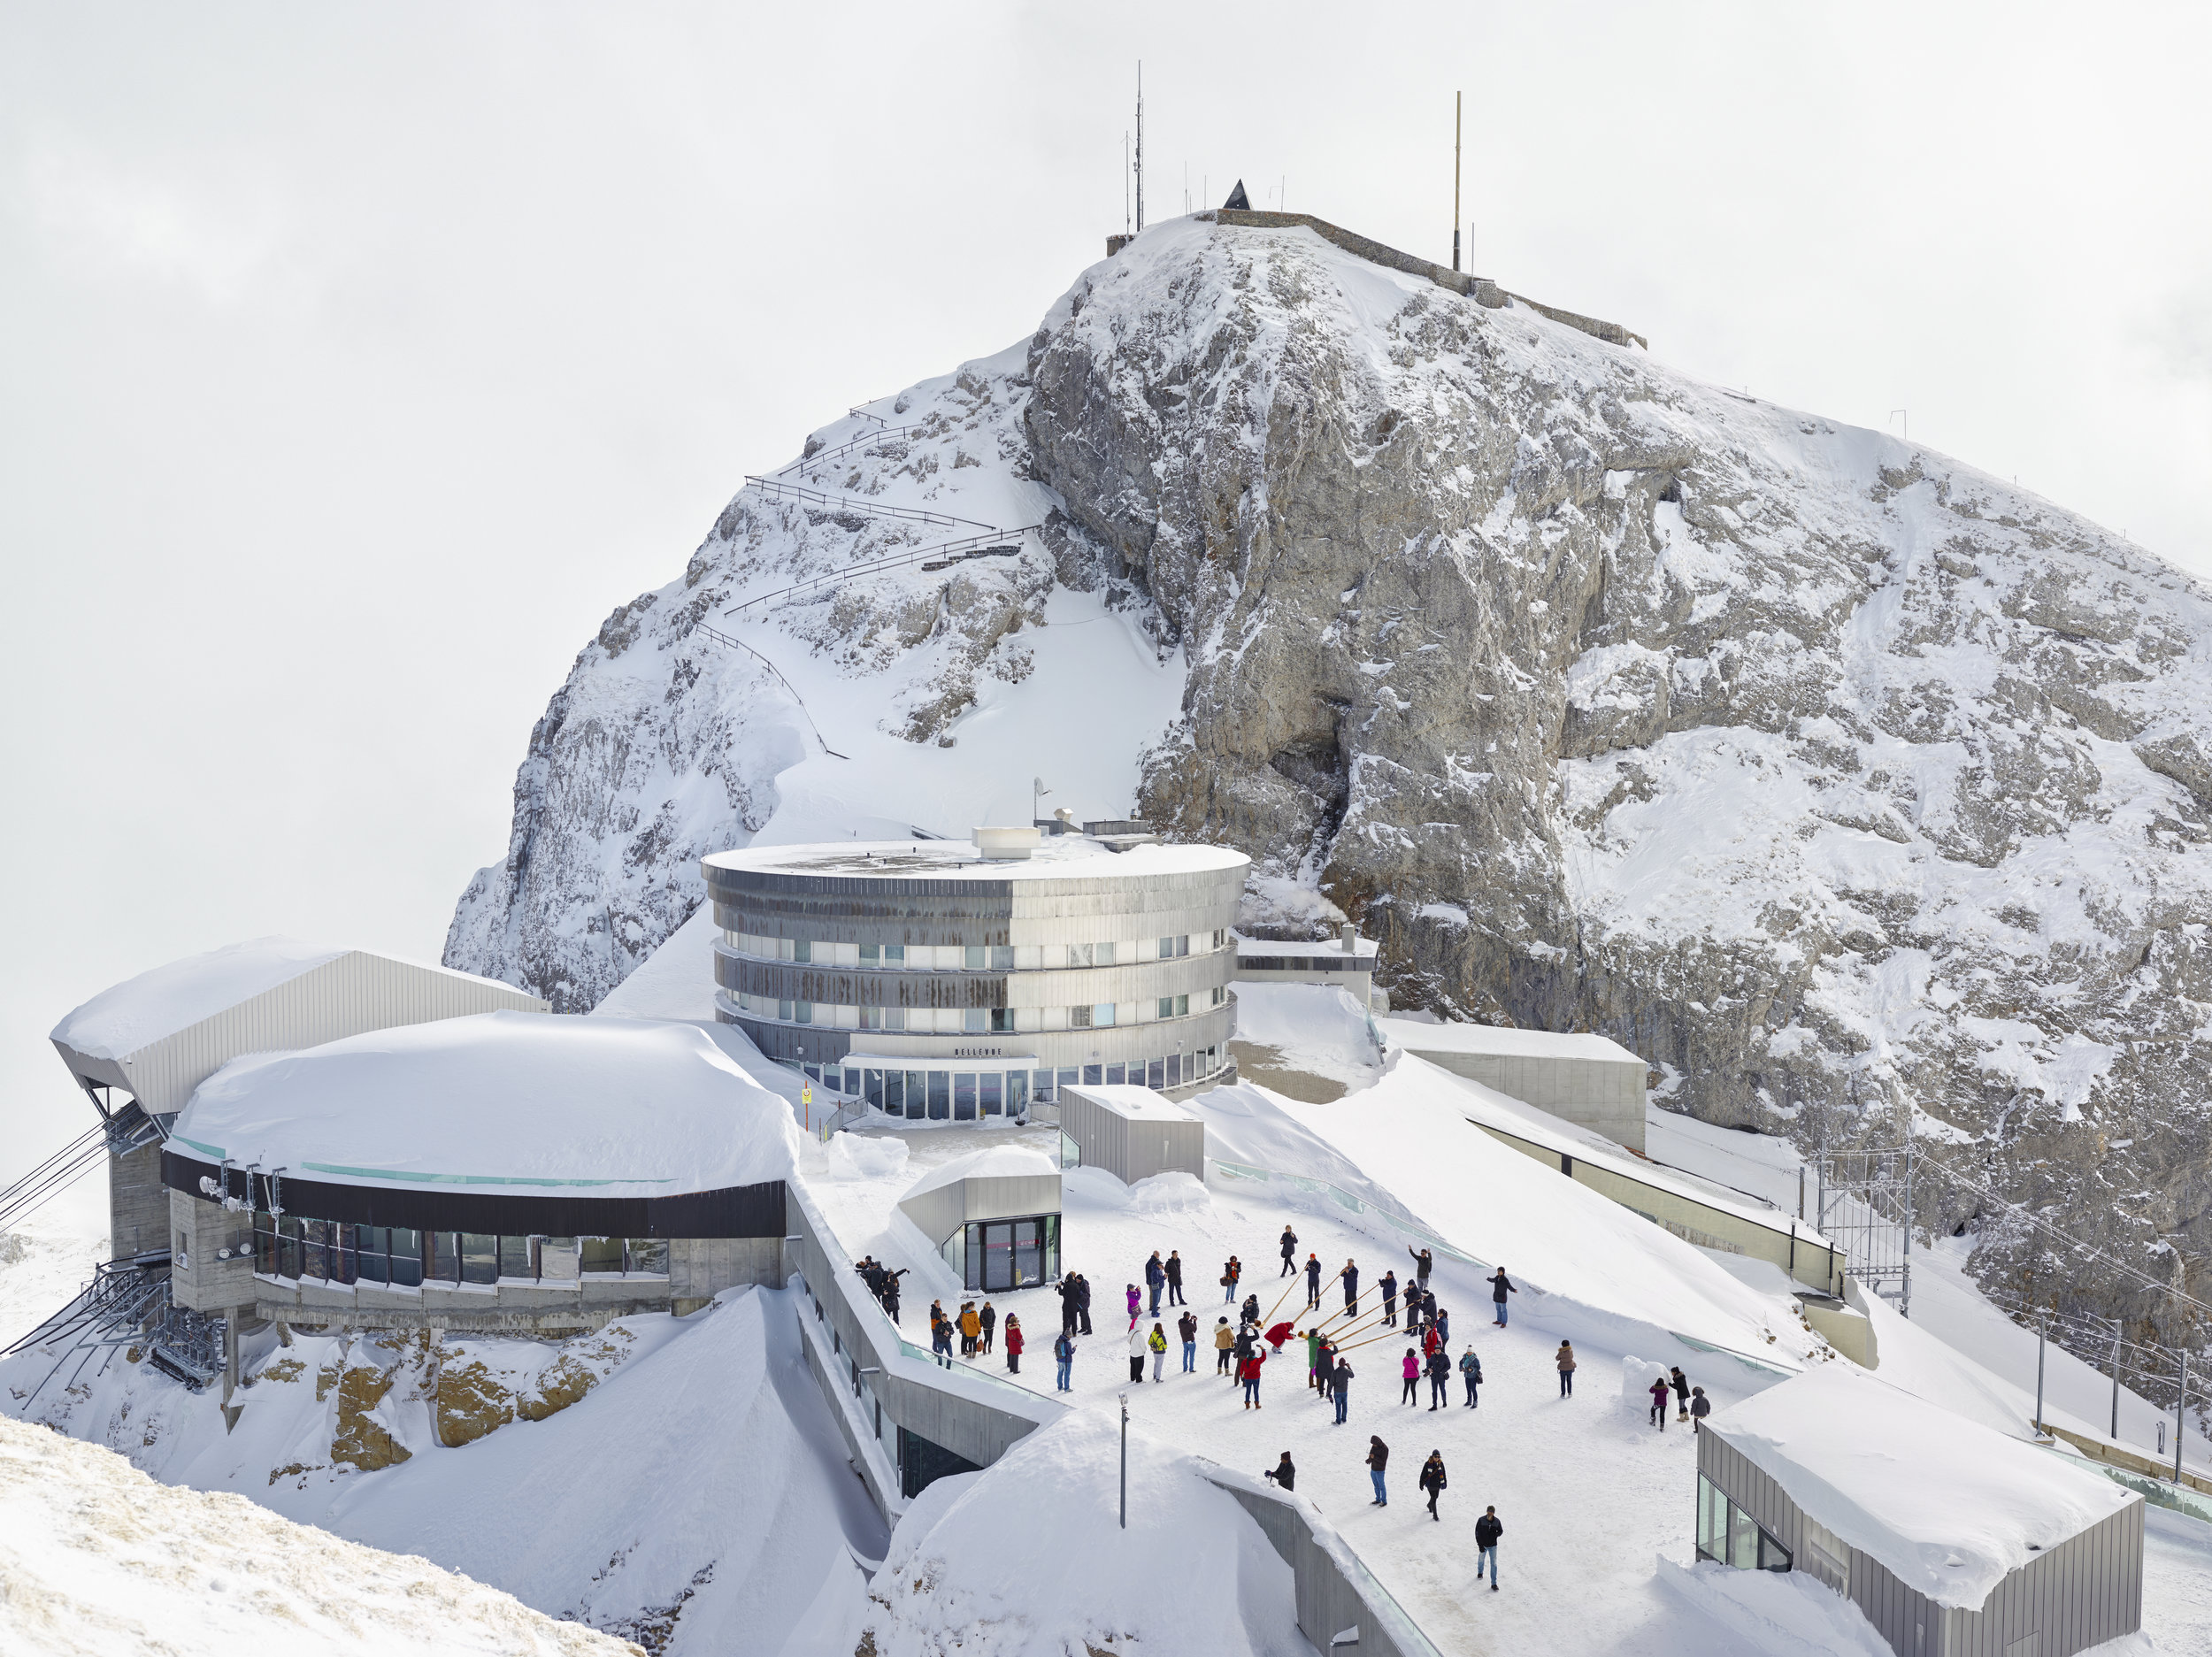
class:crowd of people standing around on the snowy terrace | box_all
[854,1225,1712,1592]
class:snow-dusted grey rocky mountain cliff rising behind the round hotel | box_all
[447,219,2212,1345]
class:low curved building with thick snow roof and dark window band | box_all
[162,1013,796,1334]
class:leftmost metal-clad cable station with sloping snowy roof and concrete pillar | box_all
[53,938,547,1259]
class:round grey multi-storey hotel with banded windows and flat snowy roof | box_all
[702,830,1250,1122]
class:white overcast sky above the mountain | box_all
[0,0,2212,1212]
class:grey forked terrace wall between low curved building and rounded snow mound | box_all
[786,1181,1066,1517]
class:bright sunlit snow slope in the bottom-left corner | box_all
[0,1418,637,1657]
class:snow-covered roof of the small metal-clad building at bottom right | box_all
[1706,1362,2144,1610]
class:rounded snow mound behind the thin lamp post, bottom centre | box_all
[854,1411,1312,1657]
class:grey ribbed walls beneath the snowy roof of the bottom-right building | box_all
[1697,1423,2144,1657]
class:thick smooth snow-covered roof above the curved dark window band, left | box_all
[171,1013,796,1197]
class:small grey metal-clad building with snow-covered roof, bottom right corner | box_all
[1697,1365,2144,1657]
